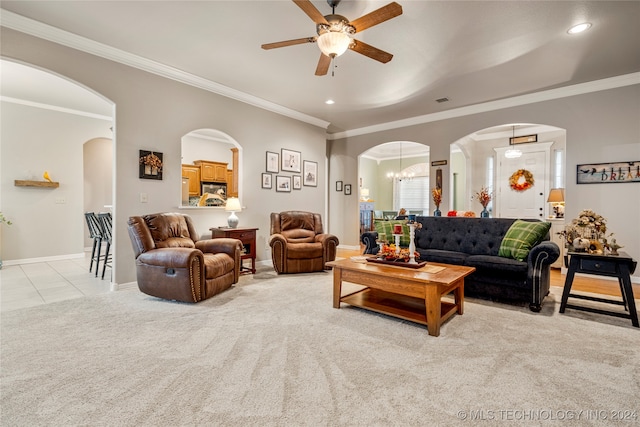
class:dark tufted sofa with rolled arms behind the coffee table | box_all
[361,216,560,312]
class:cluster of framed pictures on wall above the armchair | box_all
[261,148,318,193]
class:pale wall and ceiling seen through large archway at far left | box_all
[1,59,115,276]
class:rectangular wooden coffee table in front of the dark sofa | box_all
[327,258,475,337]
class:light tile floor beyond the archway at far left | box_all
[0,253,111,311]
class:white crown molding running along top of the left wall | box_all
[0,10,329,129]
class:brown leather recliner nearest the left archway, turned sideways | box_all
[129,213,242,302]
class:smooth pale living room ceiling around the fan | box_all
[1,0,640,134]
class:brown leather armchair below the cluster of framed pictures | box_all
[269,211,339,274]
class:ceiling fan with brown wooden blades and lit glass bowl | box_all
[262,0,402,76]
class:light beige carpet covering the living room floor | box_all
[0,268,640,426]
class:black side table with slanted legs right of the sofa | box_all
[560,252,640,328]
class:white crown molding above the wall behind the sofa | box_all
[327,73,640,140]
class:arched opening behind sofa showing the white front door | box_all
[449,123,566,219]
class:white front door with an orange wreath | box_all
[495,143,551,220]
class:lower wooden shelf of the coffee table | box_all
[340,288,458,325]
